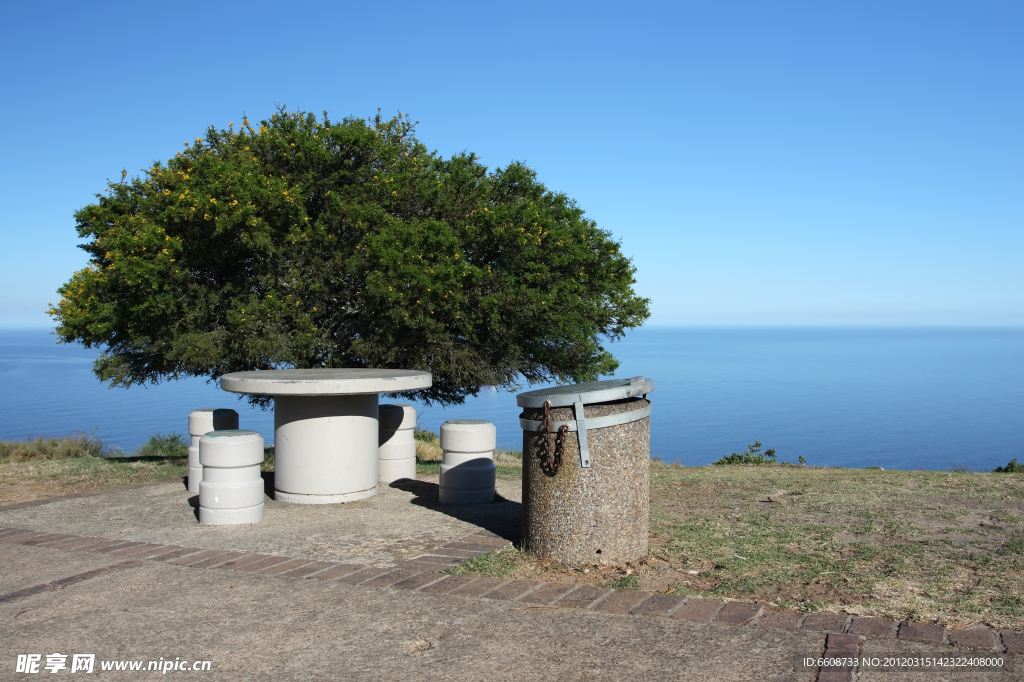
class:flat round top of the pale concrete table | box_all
[220,369,431,395]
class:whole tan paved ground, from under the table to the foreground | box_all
[0,481,1022,682]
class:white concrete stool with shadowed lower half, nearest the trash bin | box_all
[439,419,498,505]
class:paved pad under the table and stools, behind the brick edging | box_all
[0,477,520,566]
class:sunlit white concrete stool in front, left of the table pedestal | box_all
[199,431,263,525]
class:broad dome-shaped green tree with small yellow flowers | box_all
[50,109,649,403]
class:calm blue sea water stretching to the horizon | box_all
[0,328,1024,470]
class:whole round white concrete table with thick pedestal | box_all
[220,370,431,505]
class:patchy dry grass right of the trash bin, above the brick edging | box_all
[457,462,1024,630]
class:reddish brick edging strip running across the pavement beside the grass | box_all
[0,520,1024,655]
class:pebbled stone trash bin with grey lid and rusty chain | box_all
[516,377,654,565]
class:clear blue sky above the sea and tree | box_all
[0,1,1024,327]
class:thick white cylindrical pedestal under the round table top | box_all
[273,393,378,505]
